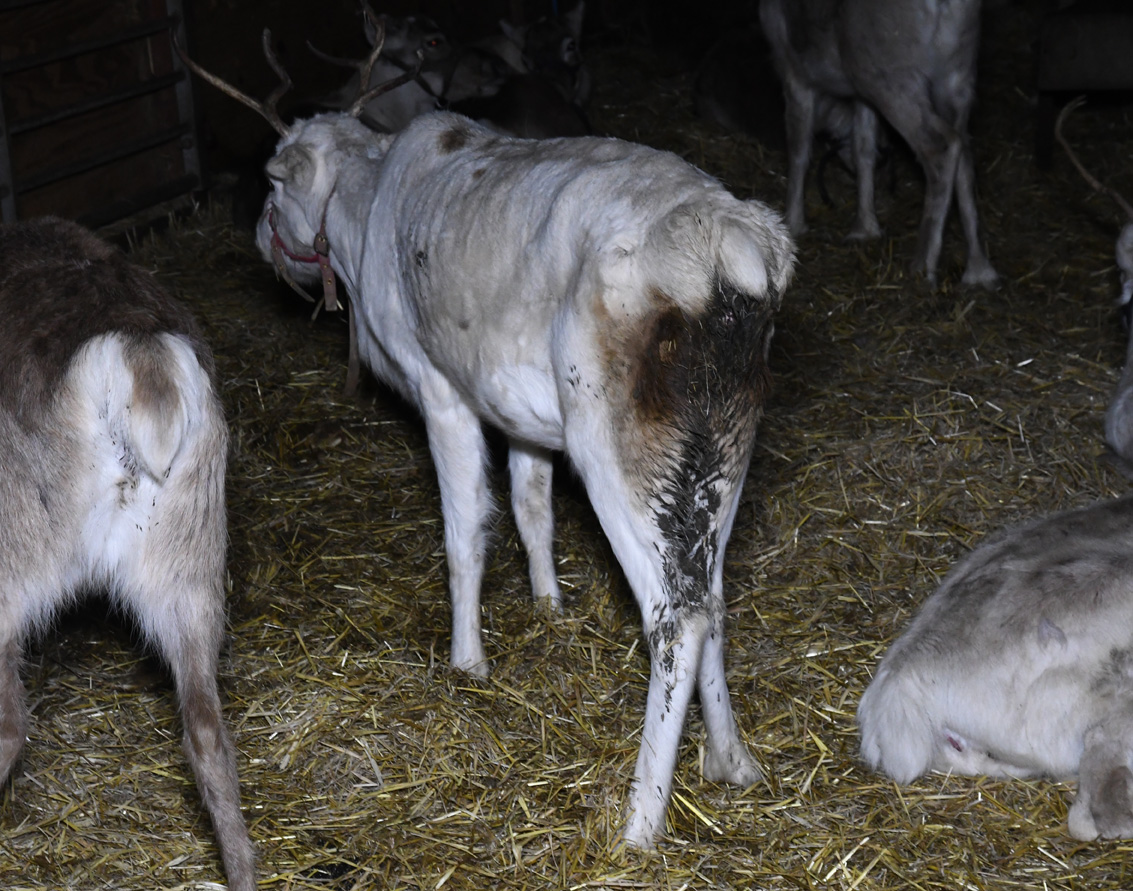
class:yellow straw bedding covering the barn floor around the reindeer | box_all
[0,2,1133,891]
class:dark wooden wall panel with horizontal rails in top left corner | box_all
[0,0,204,224]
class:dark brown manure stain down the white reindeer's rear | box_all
[597,282,774,662]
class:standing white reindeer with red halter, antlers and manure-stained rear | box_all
[181,17,794,847]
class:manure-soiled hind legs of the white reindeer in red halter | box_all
[557,279,770,848]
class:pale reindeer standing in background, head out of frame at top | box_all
[759,0,998,287]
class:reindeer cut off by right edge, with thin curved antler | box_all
[1055,99,1133,478]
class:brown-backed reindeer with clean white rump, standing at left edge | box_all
[0,218,256,891]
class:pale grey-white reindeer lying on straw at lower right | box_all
[858,498,1133,840]
